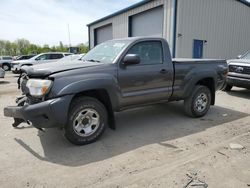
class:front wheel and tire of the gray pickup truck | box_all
[65,97,108,145]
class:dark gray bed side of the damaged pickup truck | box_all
[172,58,227,99]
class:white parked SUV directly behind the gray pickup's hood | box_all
[12,52,71,74]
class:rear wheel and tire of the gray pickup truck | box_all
[184,85,211,118]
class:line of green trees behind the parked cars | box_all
[0,39,89,56]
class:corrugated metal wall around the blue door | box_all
[176,0,250,59]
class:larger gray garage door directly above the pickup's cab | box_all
[129,6,163,37]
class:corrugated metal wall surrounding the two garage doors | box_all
[90,0,168,48]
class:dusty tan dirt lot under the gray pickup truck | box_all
[0,74,250,188]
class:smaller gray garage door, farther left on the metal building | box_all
[95,24,113,45]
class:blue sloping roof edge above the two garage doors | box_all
[87,0,152,27]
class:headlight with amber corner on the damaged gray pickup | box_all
[26,79,52,97]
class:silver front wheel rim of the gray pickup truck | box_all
[73,108,100,137]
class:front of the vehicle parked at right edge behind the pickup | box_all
[224,51,250,91]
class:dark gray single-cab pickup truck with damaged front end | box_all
[4,37,228,145]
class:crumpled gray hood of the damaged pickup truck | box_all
[21,61,103,78]
